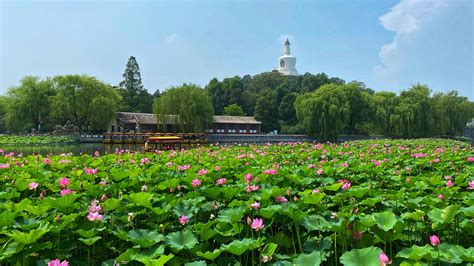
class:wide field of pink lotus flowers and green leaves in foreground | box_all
[0,140,474,265]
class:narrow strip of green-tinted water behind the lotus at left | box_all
[0,143,143,155]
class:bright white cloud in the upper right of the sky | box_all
[373,0,447,84]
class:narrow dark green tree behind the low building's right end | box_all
[255,89,280,132]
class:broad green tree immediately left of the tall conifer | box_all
[52,75,121,132]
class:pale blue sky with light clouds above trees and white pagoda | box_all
[0,0,474,101]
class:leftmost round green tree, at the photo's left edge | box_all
[4,76,54,132]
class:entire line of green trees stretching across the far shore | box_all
[0,57,474,140]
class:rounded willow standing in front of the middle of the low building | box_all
[153,84,214,132]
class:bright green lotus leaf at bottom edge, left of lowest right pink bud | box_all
[340,247,382,266]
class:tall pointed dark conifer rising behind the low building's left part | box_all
[119,56,153,113]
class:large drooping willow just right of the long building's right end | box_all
[295,84,350,141]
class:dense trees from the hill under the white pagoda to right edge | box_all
[206,72,474,140]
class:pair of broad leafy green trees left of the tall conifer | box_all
[0,75,120,133]
